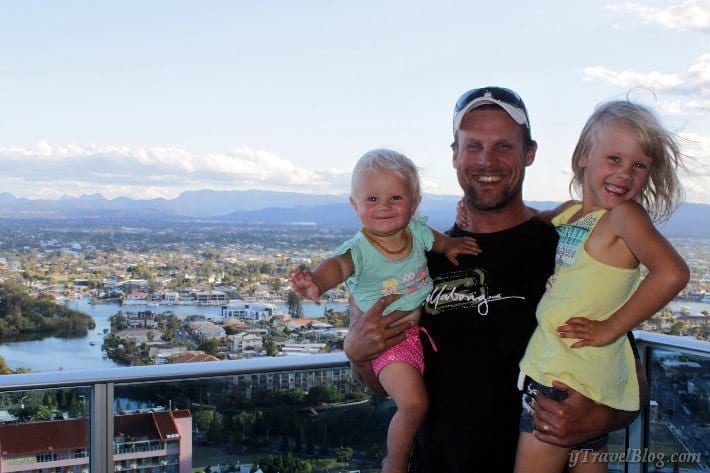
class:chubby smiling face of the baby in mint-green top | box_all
[350,169,419,236]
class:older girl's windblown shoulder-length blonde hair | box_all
[570,100,685,222]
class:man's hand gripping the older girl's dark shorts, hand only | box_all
[533,381,622,447]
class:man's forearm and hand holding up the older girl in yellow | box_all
[534,350,650,447]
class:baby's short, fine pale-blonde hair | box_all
[350,149,422,205]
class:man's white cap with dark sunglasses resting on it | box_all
[454,87,530,139]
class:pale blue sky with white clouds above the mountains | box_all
[0,0,710,204]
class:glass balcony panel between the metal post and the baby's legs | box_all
[113,365,395,472]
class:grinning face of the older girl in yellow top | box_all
[580,124,653,210]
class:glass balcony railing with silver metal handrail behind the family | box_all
[0,332,710,473]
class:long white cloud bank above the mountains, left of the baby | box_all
[0,141,350,199]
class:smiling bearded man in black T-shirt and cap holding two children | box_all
[345,87,652,472]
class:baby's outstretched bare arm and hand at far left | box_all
[288,251,355,303]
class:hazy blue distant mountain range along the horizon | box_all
[0,190,710,237]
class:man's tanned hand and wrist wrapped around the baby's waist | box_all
[343,294,414,396]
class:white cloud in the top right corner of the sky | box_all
[607,0,710,33]
